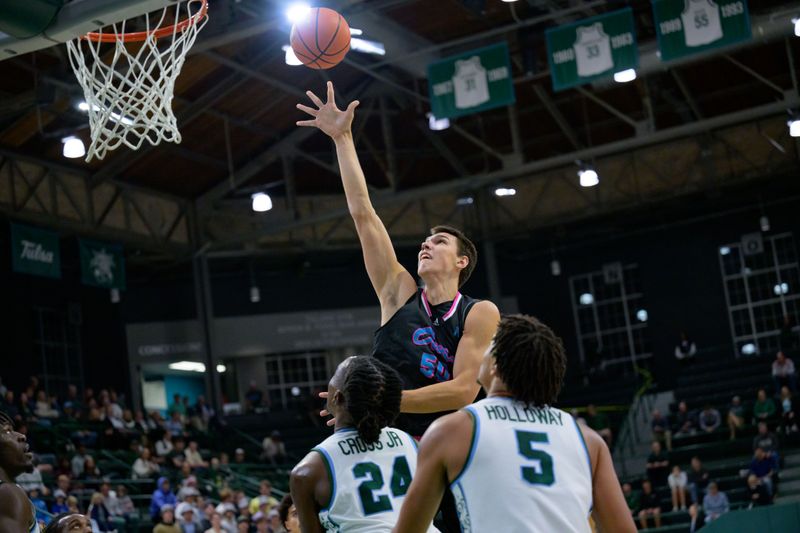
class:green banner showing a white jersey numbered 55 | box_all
[653,0,751,61]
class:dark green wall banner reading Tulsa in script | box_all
[11,224,61,278]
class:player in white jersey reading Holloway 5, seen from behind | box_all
[394,315,636,533]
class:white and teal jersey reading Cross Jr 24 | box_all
[313,427,438,533]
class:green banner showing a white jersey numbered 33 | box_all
[545,7,639,91]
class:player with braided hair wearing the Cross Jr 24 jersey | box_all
[290,356,437,533]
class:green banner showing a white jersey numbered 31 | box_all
[428,43,516,119]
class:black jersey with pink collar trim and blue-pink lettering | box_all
[372,289,480,437]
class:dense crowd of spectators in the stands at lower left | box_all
[0,377,299,533]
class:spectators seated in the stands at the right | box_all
[623,350,798,531]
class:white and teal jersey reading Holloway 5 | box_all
[450,396,592,533]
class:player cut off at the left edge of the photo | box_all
[0,412,41,533]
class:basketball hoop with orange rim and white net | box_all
[67,0,208,162]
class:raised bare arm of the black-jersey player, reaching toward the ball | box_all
[297,82,417,324]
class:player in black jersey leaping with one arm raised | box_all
[297,82,500,531]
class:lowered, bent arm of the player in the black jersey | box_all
[400,300,500,413]
